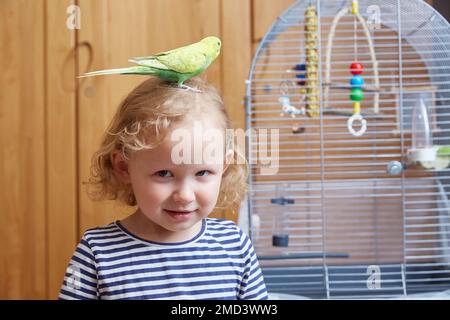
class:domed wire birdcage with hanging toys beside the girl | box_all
[246,0,450,298]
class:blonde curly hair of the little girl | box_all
[85,77,248,209]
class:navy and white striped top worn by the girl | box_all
[59,218,268,300]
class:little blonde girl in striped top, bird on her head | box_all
[59,78,268,299]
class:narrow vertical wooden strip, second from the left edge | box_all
[45,0,78,299]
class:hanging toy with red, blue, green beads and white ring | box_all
[347,62,367,137]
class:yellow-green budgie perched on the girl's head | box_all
[80,37,222,91]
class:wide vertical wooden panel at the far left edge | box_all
[0,0,47,299]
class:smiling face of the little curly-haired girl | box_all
[116,118,229,240]
